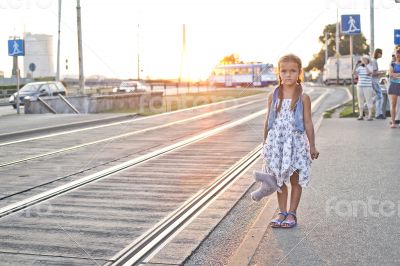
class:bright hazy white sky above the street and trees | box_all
[0,0,400,79]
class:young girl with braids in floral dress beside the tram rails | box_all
[262,54,319,228]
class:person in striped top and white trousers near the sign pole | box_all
[353,55,374,121]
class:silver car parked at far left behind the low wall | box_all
[8,81,67,108]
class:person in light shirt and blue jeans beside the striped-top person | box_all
[371,48,386,119]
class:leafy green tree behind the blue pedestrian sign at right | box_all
[304,23,369,71]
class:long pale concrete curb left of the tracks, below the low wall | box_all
[0,114,136,140]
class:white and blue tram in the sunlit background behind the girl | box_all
[210,63,278,87]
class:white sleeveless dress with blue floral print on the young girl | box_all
[262,99,311,187]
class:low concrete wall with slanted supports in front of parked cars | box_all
[25,92,163,114]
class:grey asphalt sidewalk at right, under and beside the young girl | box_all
[238,118,400,265]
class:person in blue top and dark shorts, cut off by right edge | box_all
[388,47,400,128]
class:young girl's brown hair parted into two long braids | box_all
[276,54,303,112]
